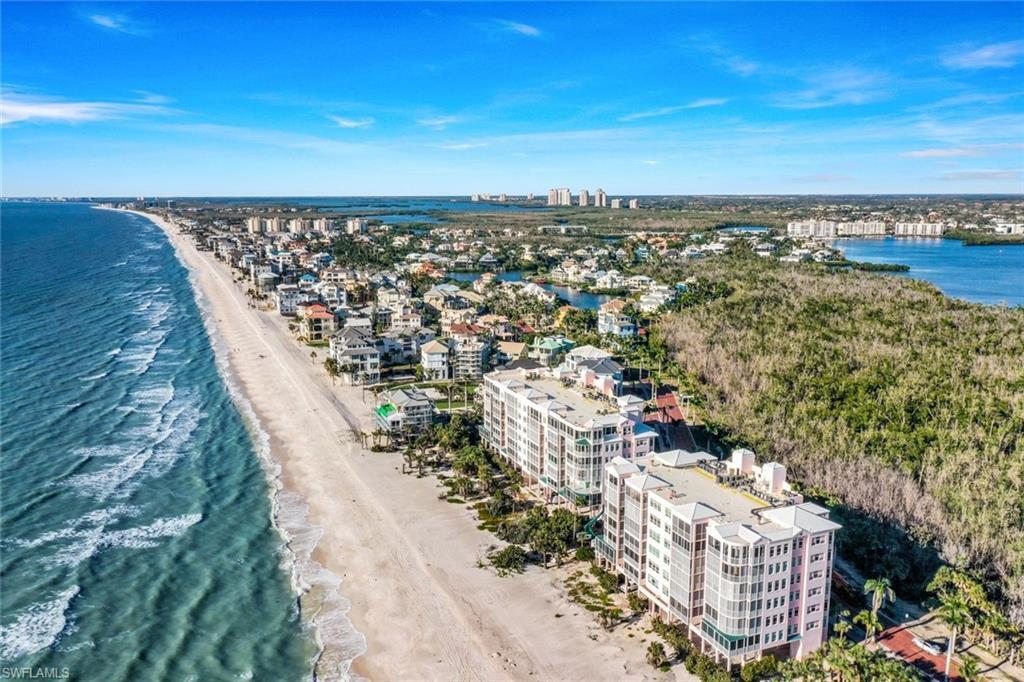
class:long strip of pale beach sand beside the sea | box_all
[130,208,693,680]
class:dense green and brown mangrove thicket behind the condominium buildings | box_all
[658,254,1024,623]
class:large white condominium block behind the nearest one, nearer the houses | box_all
[480,369,656,504]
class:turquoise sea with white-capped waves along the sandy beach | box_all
[0,203,316,681]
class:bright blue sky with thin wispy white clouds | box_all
[0,2,1024,196]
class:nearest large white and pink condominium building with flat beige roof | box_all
[595,450,841,666]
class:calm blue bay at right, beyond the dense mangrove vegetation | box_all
[833,237,1024,305]
